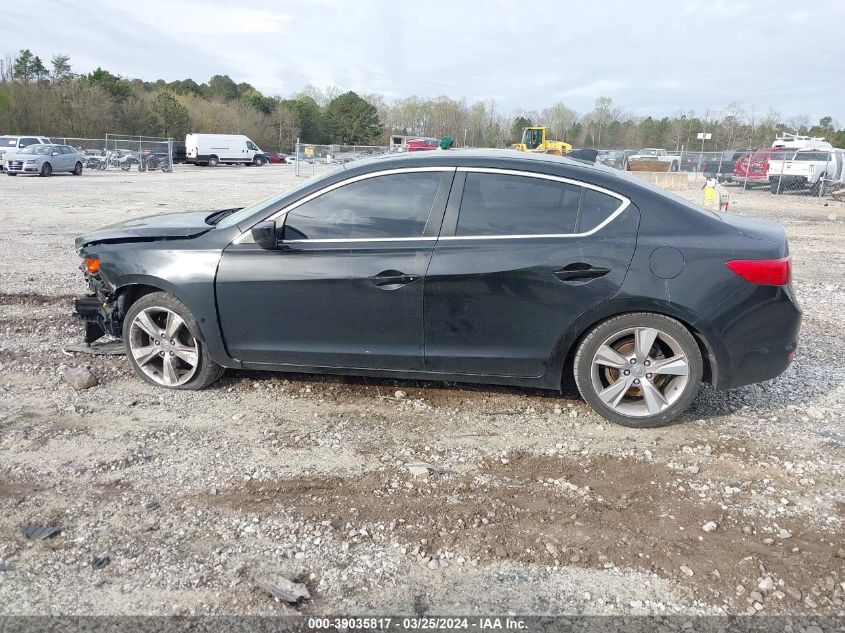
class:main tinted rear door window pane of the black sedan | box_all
[455,173,581,236]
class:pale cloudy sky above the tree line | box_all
[0,0,845,126]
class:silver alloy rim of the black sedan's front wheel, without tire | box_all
[129,306,199,387]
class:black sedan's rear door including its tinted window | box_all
[424,168,639,377]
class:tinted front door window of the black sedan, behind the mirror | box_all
[283,172,443,240]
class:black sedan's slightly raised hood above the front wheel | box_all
[76,211,214,249]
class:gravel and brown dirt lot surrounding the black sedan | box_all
[0,166,845,615]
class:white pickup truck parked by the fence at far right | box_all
[769,149,845,196]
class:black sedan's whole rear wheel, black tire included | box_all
[573,312,704,428]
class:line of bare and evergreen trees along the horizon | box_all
[0,49,845,151]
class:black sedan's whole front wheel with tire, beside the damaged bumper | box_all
[123,292,225,390]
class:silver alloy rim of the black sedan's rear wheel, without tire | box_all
[590,327,690,417]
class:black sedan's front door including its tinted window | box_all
[217,168,454,371]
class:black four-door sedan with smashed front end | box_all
[76,151,801,426]
